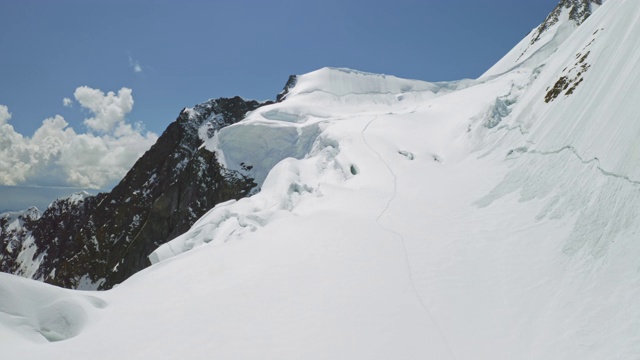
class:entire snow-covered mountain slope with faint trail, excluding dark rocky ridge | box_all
[0,0,640,360]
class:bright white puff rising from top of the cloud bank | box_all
[73,86,133,133]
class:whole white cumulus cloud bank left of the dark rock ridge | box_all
[0,86,158,188]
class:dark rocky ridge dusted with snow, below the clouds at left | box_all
[0,97,270,289]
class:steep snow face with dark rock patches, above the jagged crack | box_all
[514,1,640,179]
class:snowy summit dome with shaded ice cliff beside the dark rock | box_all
[205,68,468,188]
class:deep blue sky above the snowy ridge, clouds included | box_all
[0,0,558,209]
